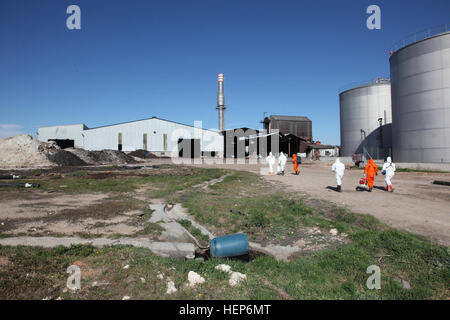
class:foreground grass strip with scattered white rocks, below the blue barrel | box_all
[0,234,450,299]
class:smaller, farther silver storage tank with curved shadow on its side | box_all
[339,79,392,159]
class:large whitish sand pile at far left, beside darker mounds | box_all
[0,134,60,169]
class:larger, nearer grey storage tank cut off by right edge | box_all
[390,32,450,163]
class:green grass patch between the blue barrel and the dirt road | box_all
[171,172,384,240]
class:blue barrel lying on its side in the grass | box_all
[210,233,250,257]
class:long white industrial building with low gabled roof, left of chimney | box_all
[38,117,223,157]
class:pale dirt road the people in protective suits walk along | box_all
[139,159,450,245]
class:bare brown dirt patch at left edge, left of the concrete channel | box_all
[0,186,155,238]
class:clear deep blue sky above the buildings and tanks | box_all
[0,0,450,144]
